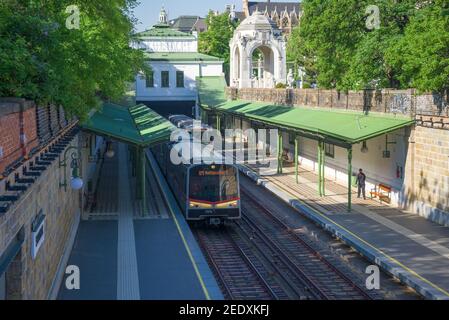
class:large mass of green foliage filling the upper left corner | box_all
[0,0,146,118]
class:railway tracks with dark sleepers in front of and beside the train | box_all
[195,188,373,300]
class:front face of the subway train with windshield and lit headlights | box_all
[186,164,241,225]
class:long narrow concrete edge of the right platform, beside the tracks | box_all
[238,165,449,300]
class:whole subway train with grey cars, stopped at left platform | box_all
[150,142,241,225]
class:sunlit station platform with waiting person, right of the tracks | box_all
[239,165,449,300]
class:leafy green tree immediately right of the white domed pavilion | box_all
[296,0,368,88]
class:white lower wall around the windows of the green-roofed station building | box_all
[136,62,223,101]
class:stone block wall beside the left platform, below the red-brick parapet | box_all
[0,136,81,300]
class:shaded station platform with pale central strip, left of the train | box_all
[58,144,223,300]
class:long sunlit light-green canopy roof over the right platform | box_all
[203,100,414,146]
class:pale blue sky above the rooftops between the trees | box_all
[134,0,298,31]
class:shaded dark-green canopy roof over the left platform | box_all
[81,103,175,147]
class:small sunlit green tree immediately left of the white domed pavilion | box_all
[198,11,237,78]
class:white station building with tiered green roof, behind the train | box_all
[135,9,223,116]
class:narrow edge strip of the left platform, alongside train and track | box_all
[146,151,224,300]
